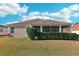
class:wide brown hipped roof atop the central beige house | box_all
[8,18,70,26]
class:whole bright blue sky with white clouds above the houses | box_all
[0,3,79,24]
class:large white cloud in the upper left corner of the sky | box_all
[0,3,28,17]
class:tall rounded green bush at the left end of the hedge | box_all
[27,27,38,40]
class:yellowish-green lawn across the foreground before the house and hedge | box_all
[0,37,79,56]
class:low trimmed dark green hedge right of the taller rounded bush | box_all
[39,32,78,40]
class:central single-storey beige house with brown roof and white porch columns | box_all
[8,19,71,37]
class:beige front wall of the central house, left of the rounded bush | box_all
[8,27,27,38]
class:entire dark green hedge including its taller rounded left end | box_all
[27,27,78,40]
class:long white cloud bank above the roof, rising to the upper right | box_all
[20,4,79,23]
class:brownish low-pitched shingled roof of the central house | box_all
[8,19,70,26]
